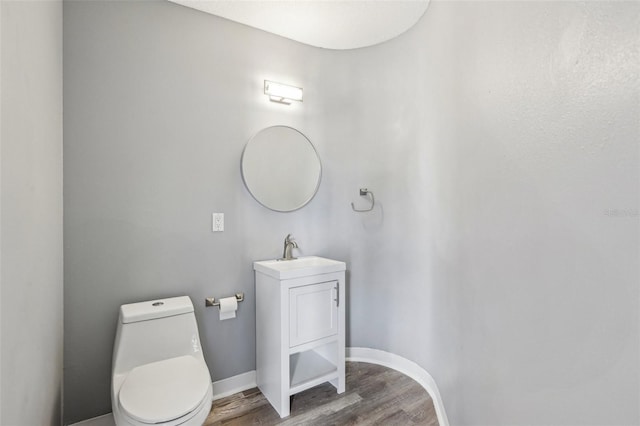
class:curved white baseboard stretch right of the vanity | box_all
[346,348,449,426]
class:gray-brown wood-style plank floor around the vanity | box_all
[204,362,438,426]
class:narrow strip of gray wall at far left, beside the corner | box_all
[0,1,63,426]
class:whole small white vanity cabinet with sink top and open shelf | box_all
[253,256,346,417]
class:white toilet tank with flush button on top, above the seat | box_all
[113,296,204,374]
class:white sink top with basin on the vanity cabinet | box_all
[253,256,347,280]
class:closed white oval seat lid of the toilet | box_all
[118,355,211,424]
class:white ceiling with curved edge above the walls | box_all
[169,0,429,49]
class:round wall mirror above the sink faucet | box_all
[241,126,322,212]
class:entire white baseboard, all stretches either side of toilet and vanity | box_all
[71,348,449,426]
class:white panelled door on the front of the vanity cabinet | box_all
[289,281,339,347]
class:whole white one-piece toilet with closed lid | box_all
[111,296,213,426]
